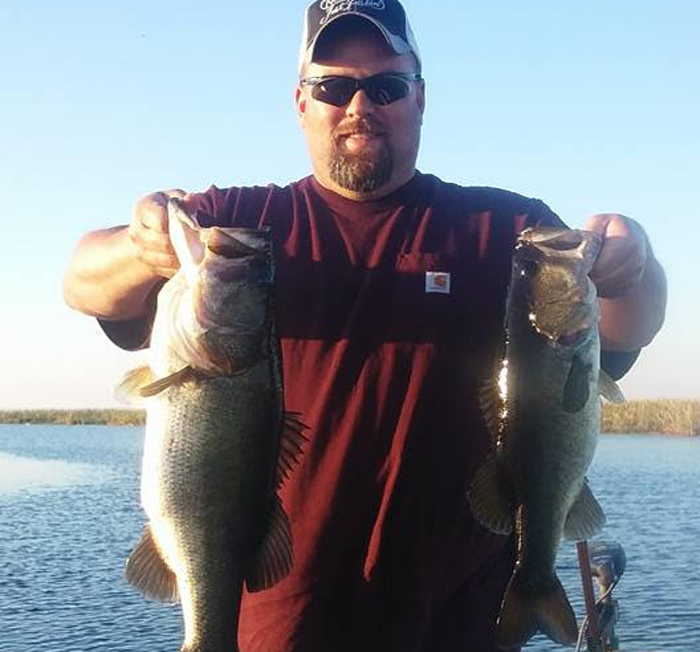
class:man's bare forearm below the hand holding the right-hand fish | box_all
[600,252,666,351]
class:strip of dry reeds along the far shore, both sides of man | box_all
[0,399,700,435]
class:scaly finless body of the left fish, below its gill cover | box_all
[142,362,280,652]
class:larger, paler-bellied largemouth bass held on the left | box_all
[120,199,304,652]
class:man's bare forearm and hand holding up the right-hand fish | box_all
[584,214,666,351]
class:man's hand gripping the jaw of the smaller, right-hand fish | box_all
[584,213,647,298]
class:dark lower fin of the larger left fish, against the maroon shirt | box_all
[246,496,293,592]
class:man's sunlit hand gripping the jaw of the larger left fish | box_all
[127,189,187,278]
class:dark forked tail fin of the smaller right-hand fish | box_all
[498,568,578,649]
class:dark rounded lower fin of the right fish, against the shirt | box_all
[469,455,515,534]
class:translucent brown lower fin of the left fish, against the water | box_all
[124,525,179,602]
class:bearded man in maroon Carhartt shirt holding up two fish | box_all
[65,0,665,652]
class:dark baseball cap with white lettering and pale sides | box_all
[299,0,421,70]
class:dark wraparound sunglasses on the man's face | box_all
[301,72,422,106]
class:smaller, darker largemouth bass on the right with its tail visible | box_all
[469,229,622,648]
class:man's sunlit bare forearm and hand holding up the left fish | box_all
[63,190,185,320]
